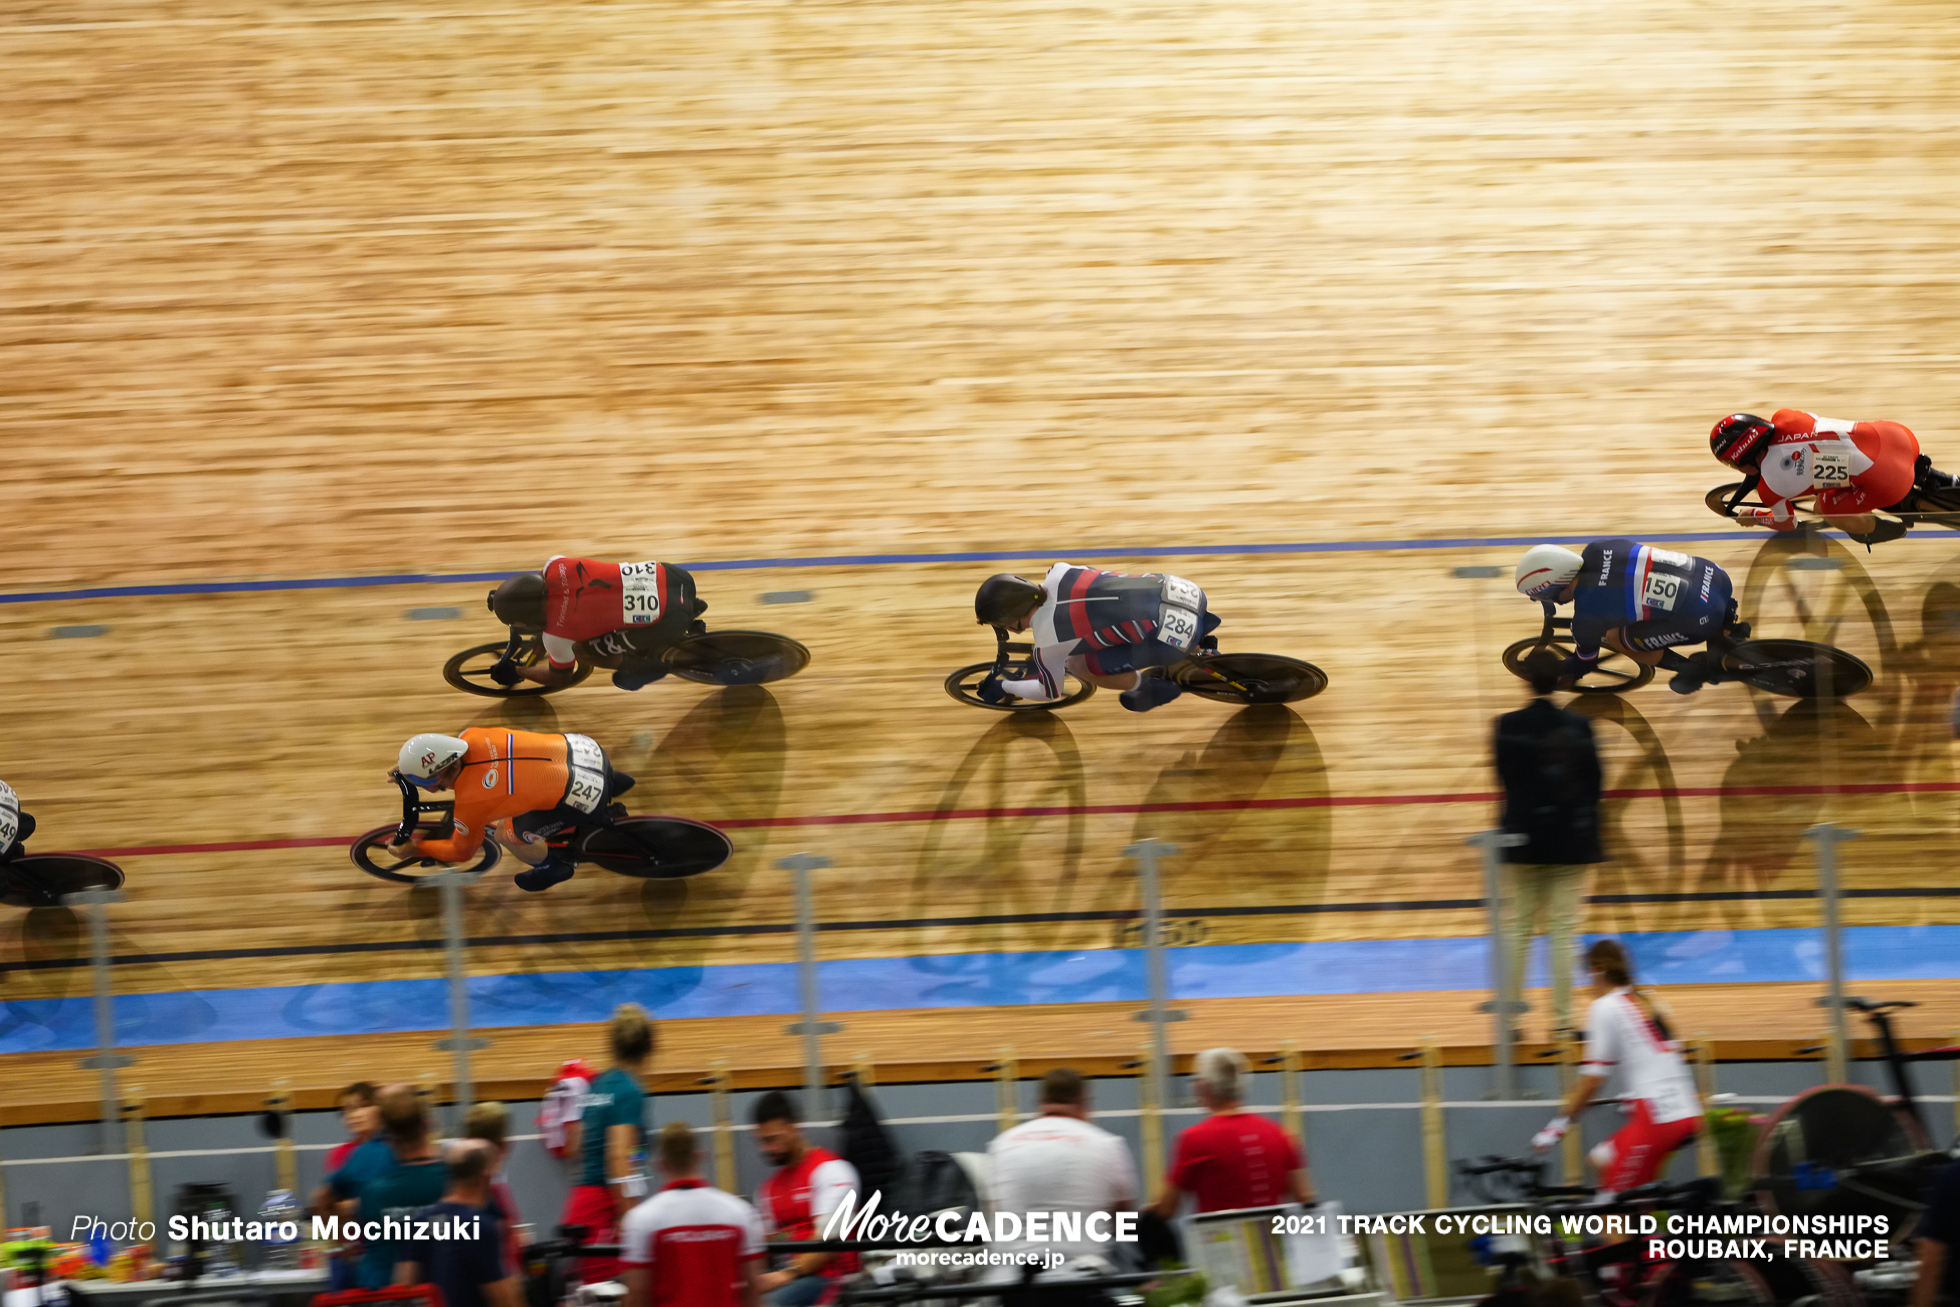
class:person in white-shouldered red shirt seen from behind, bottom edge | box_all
[619,1121,762,1307]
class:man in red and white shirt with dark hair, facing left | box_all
[749,1089,858,1307]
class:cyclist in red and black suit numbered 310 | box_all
[490,555,708,690]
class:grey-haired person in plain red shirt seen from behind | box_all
[1151,1048,1317,1221]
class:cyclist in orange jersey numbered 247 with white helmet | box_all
[388,727,633,892]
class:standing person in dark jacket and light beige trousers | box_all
[1495,651,1605,1033]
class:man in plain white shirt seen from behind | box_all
[988,1066,1137,1258]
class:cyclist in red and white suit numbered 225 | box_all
[1709,408,1960,545]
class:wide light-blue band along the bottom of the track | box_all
[0,925,1960,1054]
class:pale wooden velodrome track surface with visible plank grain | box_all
[0,0,1960,1123]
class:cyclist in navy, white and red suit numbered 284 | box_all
[974,562,1219,713]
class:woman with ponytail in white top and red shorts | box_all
[1531,939,1701,1193]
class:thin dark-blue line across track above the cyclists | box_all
[0,531,1779,604]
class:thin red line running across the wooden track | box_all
[67,780,1960,858]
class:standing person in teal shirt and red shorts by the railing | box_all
[564,1003,653,1283]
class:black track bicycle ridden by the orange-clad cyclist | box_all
[347,776,735,886]
